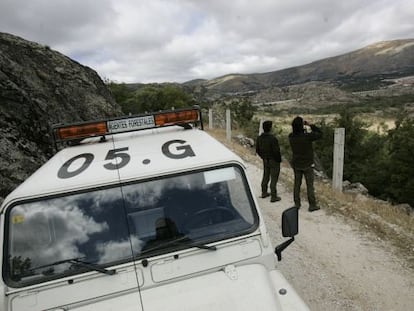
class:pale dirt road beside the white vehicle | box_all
[248,164,414,311]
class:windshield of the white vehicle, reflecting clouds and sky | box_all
[5,166,257,287]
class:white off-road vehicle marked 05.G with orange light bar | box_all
[0,107,308,311]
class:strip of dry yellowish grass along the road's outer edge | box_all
[208,129,414,268]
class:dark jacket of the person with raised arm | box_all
[289,124,322,169]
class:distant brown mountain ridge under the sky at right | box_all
[184,39,414,94]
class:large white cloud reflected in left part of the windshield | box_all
[11,204,108,269]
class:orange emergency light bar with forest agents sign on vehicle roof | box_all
[52,106,203,150]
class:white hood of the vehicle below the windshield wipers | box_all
[74,264,308,311]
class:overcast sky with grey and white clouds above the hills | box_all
[0,0,414,83]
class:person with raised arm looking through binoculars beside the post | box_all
[289,116,322,212]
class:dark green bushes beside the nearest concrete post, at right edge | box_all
[315,111,414,206]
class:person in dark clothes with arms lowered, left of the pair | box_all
[256,121,282,202]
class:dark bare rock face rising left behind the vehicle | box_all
[0,33,121,202]
